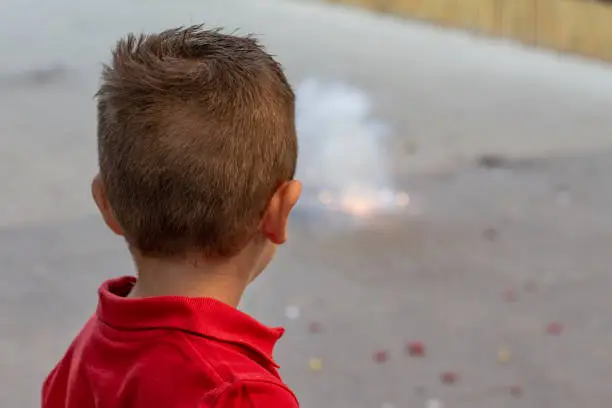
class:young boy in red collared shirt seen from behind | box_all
[42,26,301,408]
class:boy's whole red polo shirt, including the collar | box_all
[42,277,298,408]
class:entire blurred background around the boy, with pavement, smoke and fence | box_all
[0,0,612,408]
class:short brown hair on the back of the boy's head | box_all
[96,26,297,257]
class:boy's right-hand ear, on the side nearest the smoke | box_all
[261,180,302,245]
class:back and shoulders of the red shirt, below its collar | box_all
[43,317,298,408]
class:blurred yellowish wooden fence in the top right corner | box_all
[328,0,612,61]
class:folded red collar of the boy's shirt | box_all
[97,276,284,368]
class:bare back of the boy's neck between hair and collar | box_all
[129,257,249,307]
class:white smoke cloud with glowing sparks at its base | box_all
[296,80,408,217]
